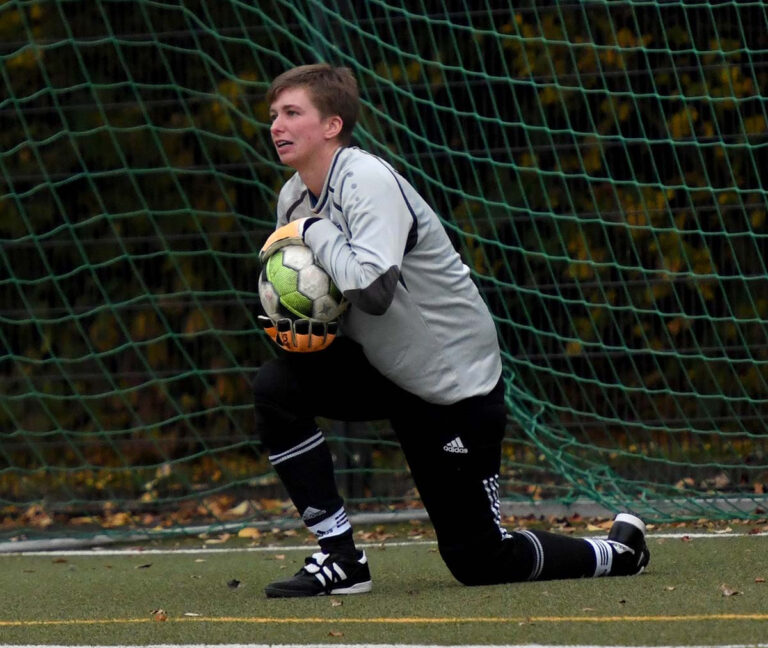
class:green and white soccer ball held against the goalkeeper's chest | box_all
[259,245,347,322]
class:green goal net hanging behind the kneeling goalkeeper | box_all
[0,0,768,538]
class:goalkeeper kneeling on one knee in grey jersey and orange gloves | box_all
[254,64,649,597]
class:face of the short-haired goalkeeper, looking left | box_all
[269,87,339,170]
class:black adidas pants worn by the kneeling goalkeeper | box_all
[253,338,594,584]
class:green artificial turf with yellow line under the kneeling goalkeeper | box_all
[0,536,768,646]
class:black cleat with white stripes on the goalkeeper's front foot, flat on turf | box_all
[264,551,371,598]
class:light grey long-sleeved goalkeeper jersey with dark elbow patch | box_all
[277,147,501,404]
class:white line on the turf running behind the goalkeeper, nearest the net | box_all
[0,532,768,560]
